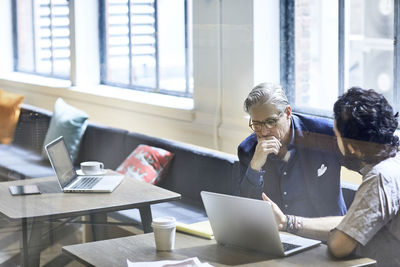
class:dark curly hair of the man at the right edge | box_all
[333,87,399,164]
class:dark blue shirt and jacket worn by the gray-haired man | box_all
[238,114,346,217]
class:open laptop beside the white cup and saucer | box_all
[45,136,124,192]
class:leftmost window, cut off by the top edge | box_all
[13,0,70,79]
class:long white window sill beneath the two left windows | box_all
[0,72,194,121]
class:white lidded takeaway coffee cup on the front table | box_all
[151,217,176,251]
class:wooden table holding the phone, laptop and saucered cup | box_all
[0,177,180,266]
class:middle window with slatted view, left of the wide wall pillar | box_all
[100,0,193,97]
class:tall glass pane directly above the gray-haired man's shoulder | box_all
[292,0,339,111]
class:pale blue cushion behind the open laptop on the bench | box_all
[42,98,89,162]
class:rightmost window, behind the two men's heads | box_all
[281,0,400,116]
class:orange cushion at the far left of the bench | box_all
[0,89,24,144]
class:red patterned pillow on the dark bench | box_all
[117,145,174,184]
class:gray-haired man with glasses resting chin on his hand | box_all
[238,83,346,217]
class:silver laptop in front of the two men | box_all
[200,191,321,256]
